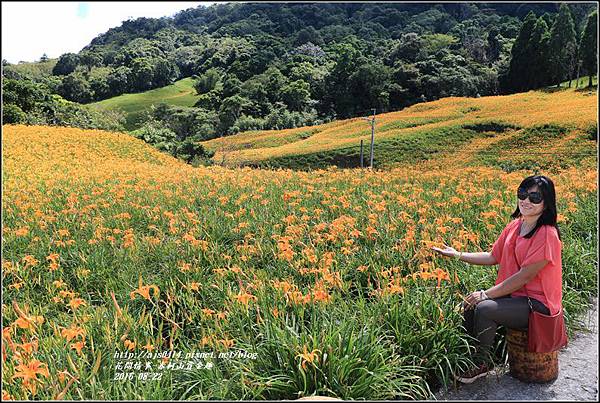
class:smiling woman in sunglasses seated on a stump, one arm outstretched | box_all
[432,176,562,383]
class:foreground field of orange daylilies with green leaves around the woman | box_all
[2,88,598,400]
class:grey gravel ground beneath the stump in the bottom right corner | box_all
[436,299,598,401]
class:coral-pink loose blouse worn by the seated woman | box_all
[492,219,562,315]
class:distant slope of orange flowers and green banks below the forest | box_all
[202,89,598,169]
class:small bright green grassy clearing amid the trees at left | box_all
[89,77,198,130]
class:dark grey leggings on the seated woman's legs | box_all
[464,296,550,360]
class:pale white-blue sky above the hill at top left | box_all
[2,1,214,63]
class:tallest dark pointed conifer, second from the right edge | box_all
[548,3,577,87]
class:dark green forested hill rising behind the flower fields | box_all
[3,3,597,150]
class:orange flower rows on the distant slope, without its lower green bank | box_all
[202,89,598,167]
